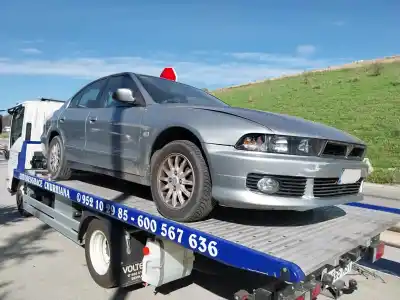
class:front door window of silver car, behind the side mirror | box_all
[103,75,143,107]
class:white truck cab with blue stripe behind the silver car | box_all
[6,98,65,194]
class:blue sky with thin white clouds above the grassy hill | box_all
[0,0,400,108]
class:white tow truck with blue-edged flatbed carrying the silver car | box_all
[7,78,400,300]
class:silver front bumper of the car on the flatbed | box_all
[203,144,368,211]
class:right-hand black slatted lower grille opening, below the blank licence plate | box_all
[313,178,363,198]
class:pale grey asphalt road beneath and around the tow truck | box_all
[0,161,400,300]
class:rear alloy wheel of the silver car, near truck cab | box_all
[47,136,71,180]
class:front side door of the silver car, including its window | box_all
[86,74,145,175]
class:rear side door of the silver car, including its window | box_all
[58,79,106,164]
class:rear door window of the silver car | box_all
[72,78,106,108]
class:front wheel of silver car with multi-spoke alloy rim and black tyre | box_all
[151,140,215,222]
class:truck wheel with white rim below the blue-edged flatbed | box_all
[85,219,120,288]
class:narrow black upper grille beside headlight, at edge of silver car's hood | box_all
[321,141,365,160]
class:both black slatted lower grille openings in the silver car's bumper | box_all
[246,173,364,198]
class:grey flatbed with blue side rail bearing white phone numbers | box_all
[14,166,399,299]
